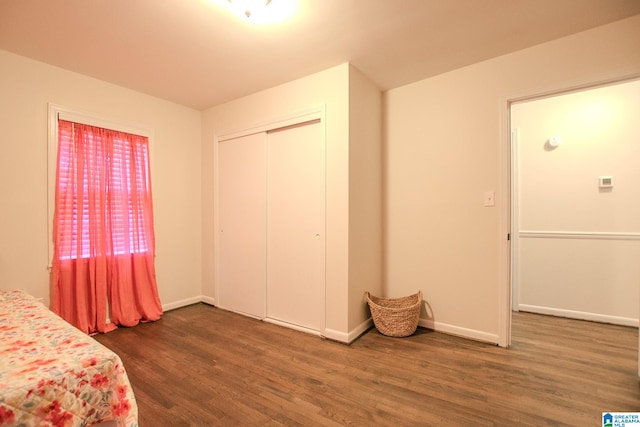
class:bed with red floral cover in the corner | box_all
[0,291,138,427]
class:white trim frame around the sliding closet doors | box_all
[213,104,327,335]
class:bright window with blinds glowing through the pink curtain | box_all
[56,120,152,259]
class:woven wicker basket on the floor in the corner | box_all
[366,291,422,337]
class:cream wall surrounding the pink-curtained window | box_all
[0,50,201,306]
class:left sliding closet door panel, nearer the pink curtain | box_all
[218,133,267,318]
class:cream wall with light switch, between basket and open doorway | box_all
[383,16,640,342]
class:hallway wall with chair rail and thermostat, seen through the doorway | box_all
[511,80,640,325]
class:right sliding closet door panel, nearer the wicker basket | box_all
[267,120,325,332]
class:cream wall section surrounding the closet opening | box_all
[201,63,349,335]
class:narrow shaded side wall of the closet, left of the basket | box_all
[349,66,382,331]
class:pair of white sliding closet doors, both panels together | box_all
[218,120,325,333]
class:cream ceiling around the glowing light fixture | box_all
[0,0,640,110]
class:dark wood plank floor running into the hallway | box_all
[96,304,640,427]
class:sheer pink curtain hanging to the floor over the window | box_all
[52,120,162,334]
